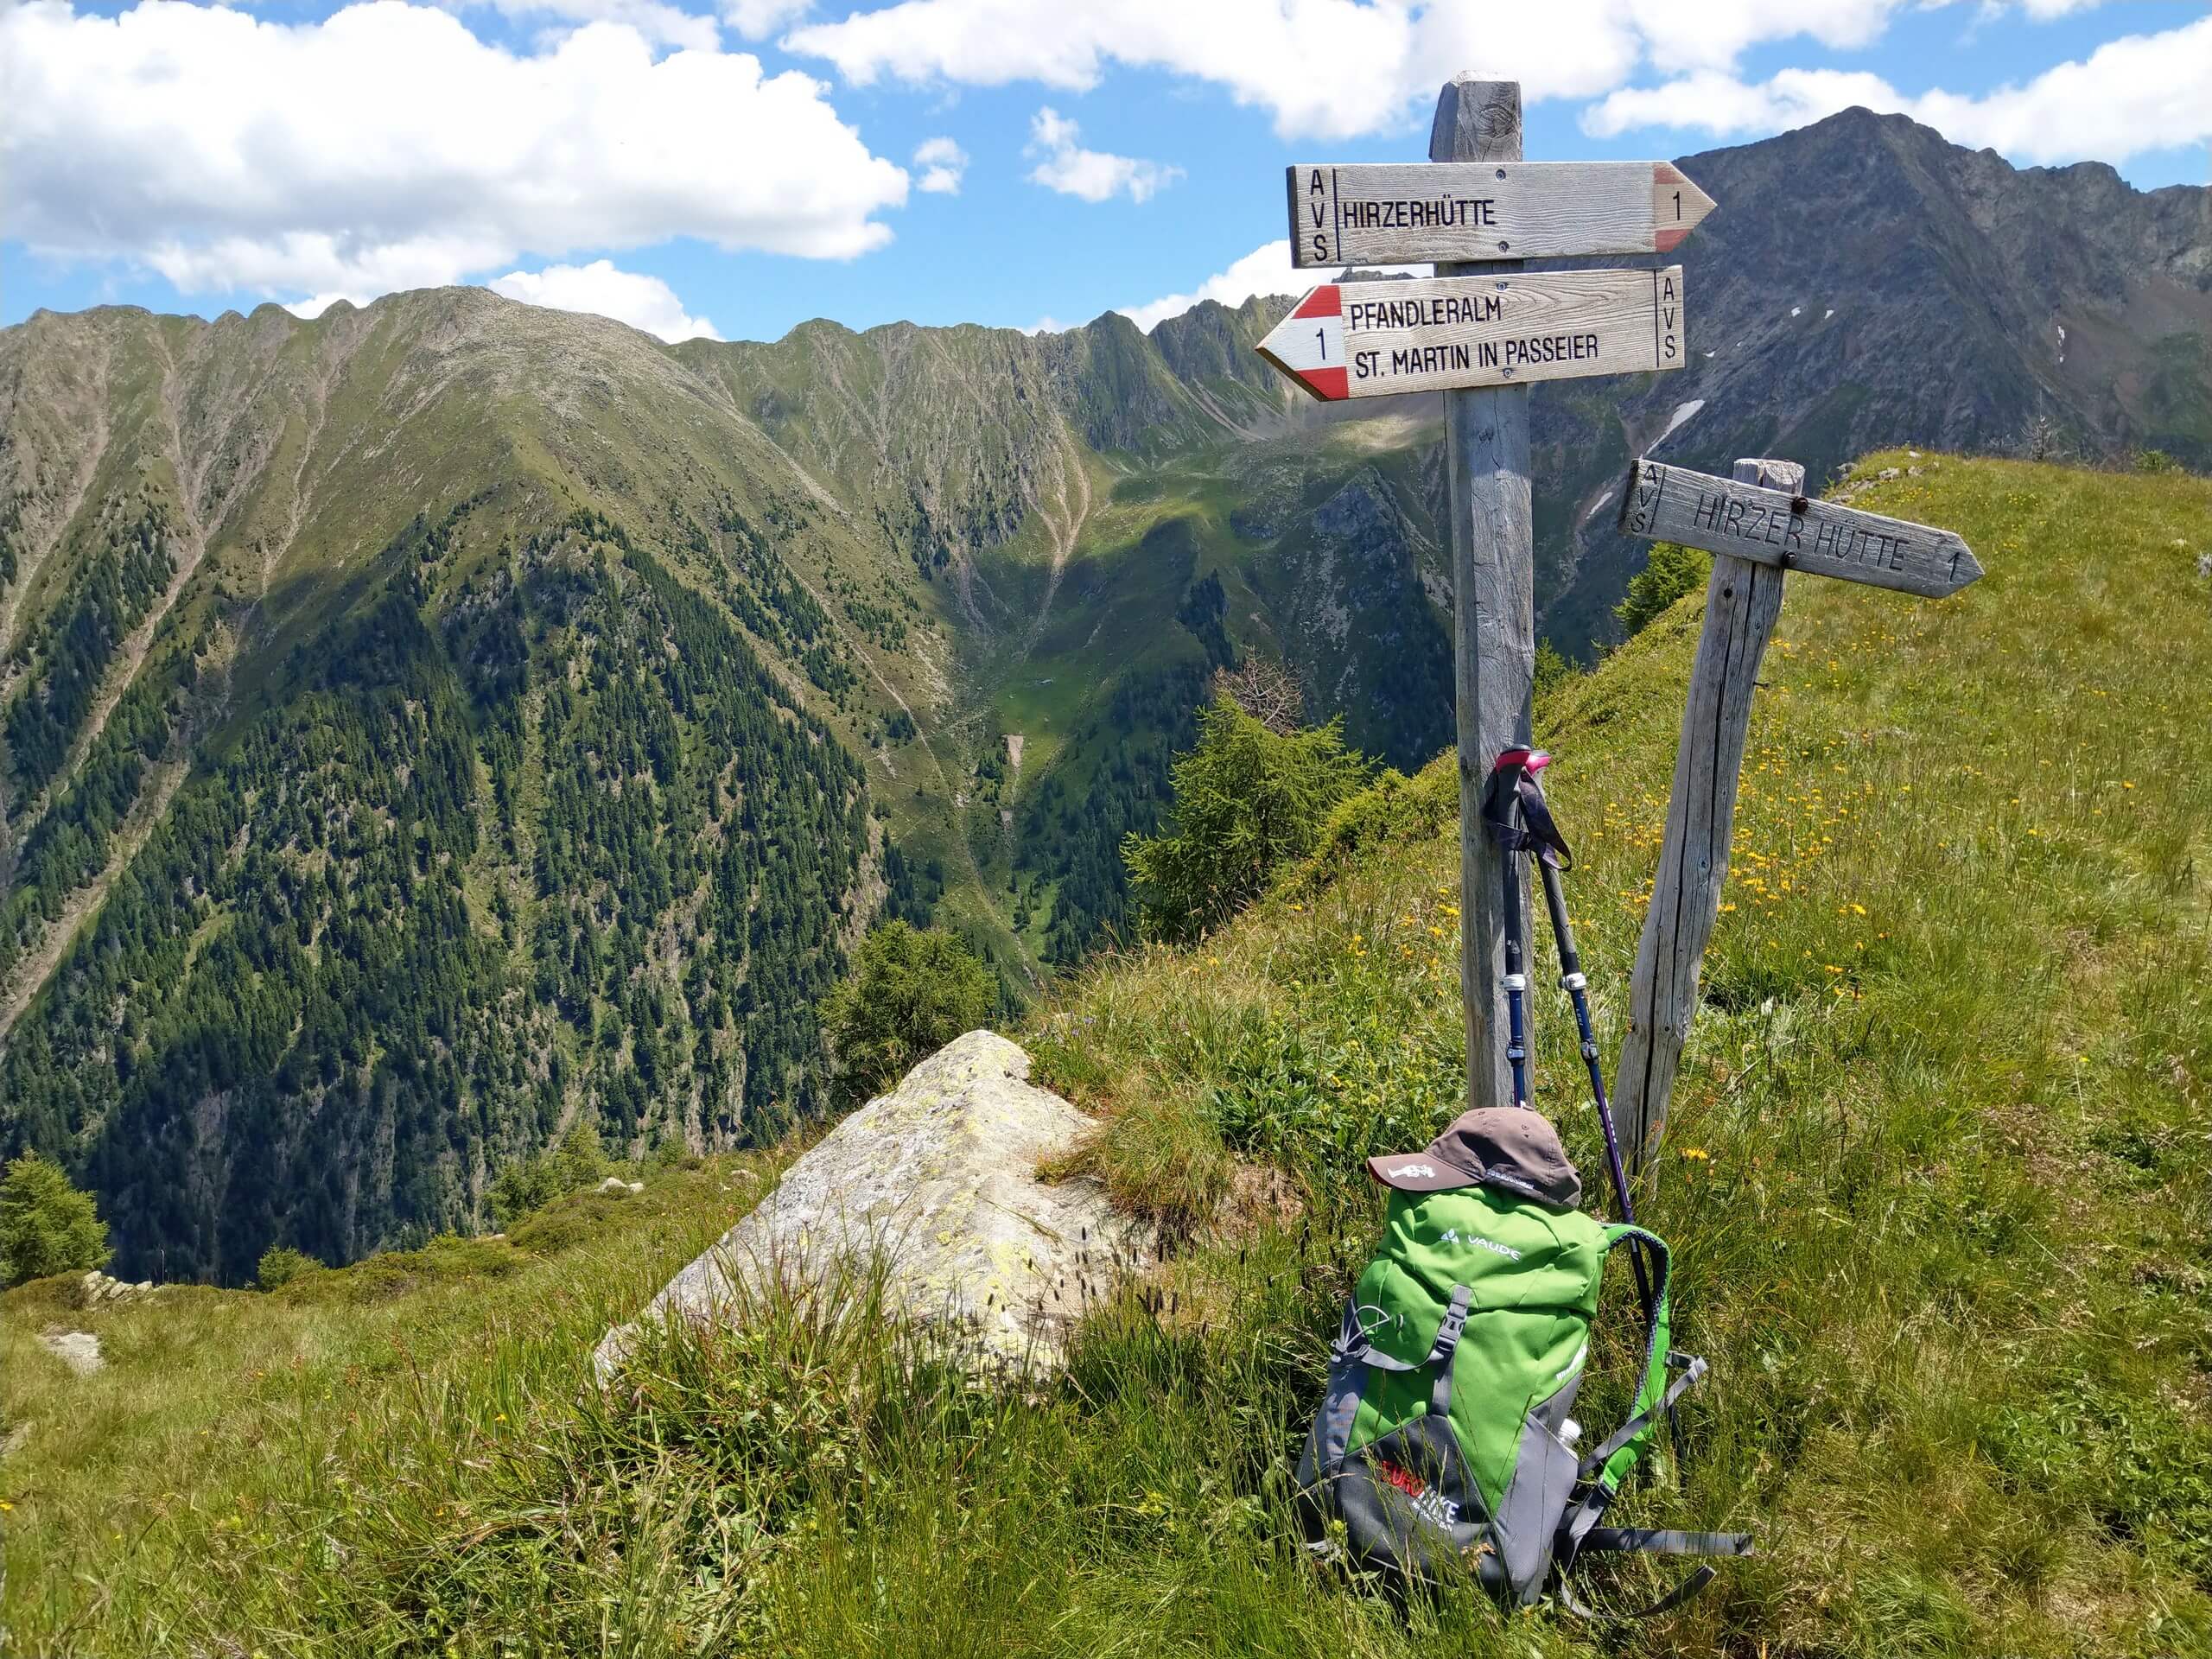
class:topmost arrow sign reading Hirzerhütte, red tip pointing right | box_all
[1287,162,1712,268]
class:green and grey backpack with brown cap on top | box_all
[1299,1106,1750,1612]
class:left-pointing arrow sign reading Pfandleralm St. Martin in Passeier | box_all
[1259,265,1686,400]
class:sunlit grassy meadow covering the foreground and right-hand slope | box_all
[0,451,2212,1659]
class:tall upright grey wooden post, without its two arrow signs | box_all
[1429,75,1535,1106]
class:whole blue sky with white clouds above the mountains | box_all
[0,0,2212,339]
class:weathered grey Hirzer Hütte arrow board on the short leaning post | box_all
[1621,460,1982,600]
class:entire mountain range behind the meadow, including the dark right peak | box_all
[0,111,2212,1276]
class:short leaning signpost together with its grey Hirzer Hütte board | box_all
[1612,448,1982,1166]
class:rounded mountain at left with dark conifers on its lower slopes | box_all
[0,292,929,1281]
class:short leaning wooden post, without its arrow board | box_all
[1612,460,1805,1166]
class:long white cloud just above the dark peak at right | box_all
[1581,17,2212,162]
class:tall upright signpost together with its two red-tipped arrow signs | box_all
[1259,75,1712,1106]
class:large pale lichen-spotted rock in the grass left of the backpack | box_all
[593,1031,1150,1382]
